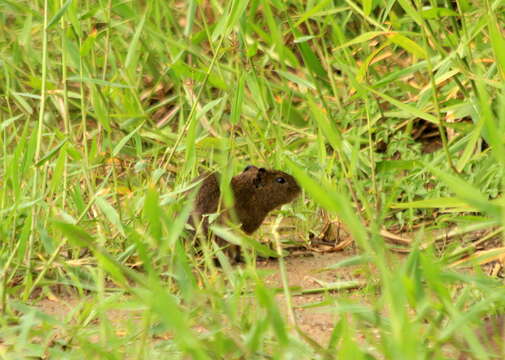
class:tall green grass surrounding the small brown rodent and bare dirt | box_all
[0,0,505,359]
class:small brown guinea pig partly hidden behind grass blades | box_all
[190,165,301,259]
